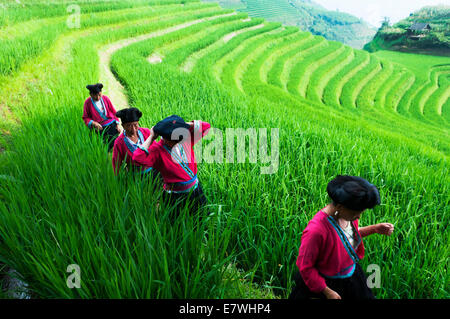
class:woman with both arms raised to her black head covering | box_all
[132,115,211,218]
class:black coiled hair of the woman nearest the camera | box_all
[327,175,381,211]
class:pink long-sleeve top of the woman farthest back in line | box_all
[83,95,119,128]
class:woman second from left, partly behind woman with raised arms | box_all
[112,107,152,175]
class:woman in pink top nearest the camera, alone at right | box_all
[289,175,394,299]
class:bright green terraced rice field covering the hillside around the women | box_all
[0,0,450,299]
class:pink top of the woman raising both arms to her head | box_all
[132,121,211,193]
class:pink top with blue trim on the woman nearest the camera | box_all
[296,211,364,293]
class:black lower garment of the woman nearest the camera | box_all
[289,264,375,299]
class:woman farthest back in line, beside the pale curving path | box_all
[83,83,122,151]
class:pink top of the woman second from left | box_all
[112,127,150,174]
